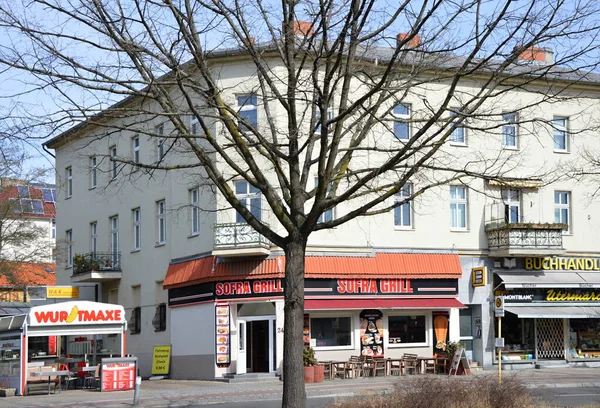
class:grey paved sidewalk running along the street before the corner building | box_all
[0,368,600,408]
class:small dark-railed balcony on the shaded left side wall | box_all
[71,252,121,283]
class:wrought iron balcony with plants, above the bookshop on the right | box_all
[485,223,567,257]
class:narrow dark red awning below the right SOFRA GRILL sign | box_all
[304,298,466,310]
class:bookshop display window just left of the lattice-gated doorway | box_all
[494,312,535,361]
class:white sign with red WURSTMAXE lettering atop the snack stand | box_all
[29,302,125,326]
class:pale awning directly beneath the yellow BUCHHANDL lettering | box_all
[495,270,600,289]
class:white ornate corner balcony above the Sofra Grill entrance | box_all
[212,223,271,258]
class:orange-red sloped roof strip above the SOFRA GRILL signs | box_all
[164,253,462,288]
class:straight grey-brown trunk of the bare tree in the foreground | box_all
[282,239,306,408]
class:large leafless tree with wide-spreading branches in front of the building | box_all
[0,0,600,407]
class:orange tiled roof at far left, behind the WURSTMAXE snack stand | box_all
[0,262,56,286]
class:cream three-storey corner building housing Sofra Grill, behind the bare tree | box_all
[46,31,600,379]
